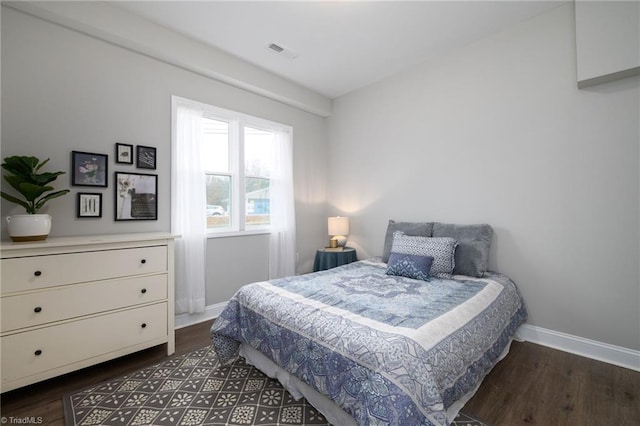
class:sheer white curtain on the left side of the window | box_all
[171,100,207,314]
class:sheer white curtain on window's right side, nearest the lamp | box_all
[269,131,296,279]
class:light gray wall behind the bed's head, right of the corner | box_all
[328,4,640,350]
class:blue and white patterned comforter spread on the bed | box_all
[211,260,527,425]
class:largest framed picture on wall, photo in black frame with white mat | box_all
[115,172,158,220]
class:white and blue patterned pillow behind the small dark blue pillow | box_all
[391,231,458,278]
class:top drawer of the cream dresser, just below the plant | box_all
[0,246,167,295]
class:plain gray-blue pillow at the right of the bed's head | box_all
[433,222,493,277]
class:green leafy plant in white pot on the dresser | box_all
[0,155,69,241]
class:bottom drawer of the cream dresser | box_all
[1,303,167,383]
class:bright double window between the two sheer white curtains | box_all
[175,96,293,234]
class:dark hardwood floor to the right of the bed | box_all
[464,342,640,426]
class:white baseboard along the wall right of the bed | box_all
[516,324,640,371]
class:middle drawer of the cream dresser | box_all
[0,274,168,333]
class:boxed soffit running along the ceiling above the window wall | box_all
[4,1,331,117]
